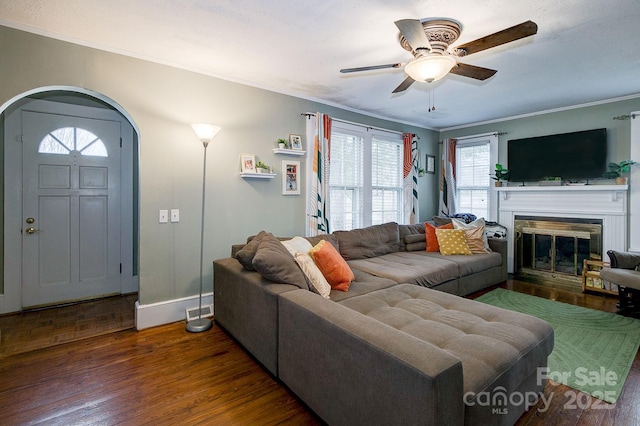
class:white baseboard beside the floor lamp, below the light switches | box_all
[135,293,213,330]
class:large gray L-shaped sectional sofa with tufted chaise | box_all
[214,223,553,425]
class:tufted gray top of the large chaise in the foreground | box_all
[340,284,553,393]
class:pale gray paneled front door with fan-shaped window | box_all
[21,110,121,307]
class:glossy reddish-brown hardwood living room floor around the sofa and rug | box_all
[0,280,640,426]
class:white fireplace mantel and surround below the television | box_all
[495,185,629,272]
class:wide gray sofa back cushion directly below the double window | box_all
[334,222,400,260]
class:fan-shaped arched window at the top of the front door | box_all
[38,127,109,157]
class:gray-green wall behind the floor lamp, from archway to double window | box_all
[0,26,438,304]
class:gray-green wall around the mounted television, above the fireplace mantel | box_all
[440,97,640,171]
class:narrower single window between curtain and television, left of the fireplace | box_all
[456,134,498,220]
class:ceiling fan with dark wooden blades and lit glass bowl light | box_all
[340,18,538,93]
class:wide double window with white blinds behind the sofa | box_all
[329,121,403,230]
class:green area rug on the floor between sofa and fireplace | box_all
[476,288,640,403]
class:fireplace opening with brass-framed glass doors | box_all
[514,215,602,283]
